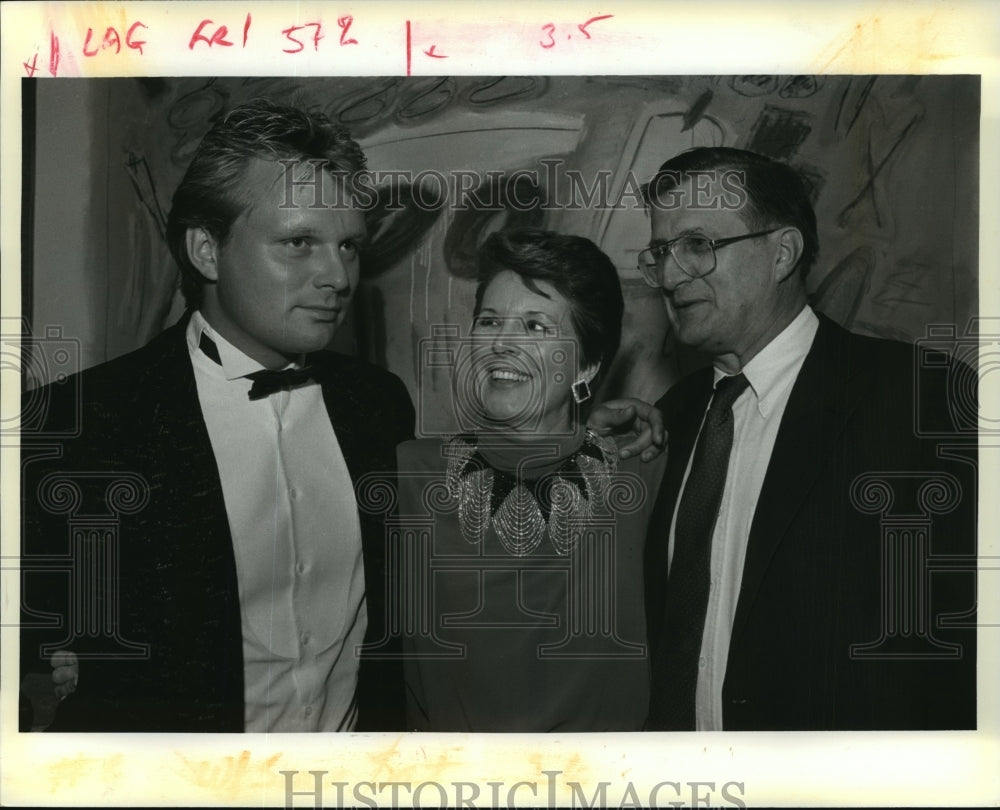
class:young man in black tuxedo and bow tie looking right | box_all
[22,102,414,732]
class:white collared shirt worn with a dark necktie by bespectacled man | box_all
[668,307,819,731]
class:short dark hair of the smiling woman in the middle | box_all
[474,228,625,380]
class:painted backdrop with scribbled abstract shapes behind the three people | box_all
[56,76,979,431]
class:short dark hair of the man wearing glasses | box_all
[646,146,819,278]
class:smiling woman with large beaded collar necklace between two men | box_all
[398,230,663,731]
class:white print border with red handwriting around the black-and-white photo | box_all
[0,0,1000,807]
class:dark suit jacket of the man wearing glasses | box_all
[646,316,976,729]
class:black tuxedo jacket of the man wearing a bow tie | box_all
[22,318,414,731]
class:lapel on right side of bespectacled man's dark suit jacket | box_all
[733,316,870,638]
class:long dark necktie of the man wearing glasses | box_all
[653,374,749,731]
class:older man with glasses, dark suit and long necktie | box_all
[640,148,976,730]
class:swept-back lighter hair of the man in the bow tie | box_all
[167,100,366,308]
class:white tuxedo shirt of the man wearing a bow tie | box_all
[187,312,368,732]
